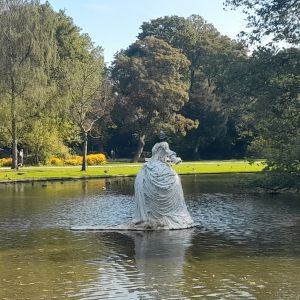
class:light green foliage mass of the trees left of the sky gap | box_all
[0,0,110,168]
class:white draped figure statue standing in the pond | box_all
[131,142,195,230]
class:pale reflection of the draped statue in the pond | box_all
[133,229,193,298]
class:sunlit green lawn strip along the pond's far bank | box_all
[0,160,264,183]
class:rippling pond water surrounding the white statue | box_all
[0,175,300,300]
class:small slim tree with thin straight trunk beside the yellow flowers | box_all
[67,45,112,171]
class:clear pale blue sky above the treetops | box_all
[42,0,245,63]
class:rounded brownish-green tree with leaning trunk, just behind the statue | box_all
[111,37,197,162]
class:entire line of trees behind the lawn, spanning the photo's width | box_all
[0,0,300,185]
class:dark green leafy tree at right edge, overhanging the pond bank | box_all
[226,48,300,174]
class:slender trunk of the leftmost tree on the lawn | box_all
[11,85,18,170]
